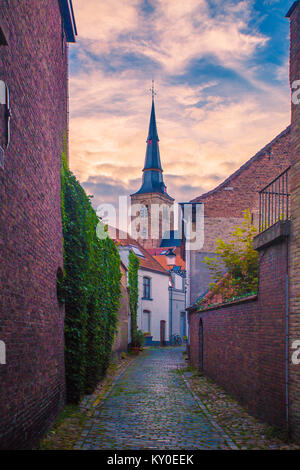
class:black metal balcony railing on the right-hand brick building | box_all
[259,167,291,232]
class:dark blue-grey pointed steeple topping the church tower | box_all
[135,81,170,194]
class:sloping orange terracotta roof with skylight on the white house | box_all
[108,227,169,276]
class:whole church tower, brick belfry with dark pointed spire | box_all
[131,81,174,249]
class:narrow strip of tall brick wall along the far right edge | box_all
[289,2,300,441]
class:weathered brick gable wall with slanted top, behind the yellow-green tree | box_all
[189,127,291,303]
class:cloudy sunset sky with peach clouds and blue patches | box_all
[69,0,293,208]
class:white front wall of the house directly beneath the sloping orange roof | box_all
[137,268,169,343]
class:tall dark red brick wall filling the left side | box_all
[0,0,67,448]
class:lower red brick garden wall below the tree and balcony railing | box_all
[190,237,287,428]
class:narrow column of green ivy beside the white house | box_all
[128,251,140,346]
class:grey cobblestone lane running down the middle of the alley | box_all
[76,348,230,450]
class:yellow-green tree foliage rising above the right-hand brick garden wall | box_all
[204,210,258,301]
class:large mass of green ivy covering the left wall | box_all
[58,152,121,403]
